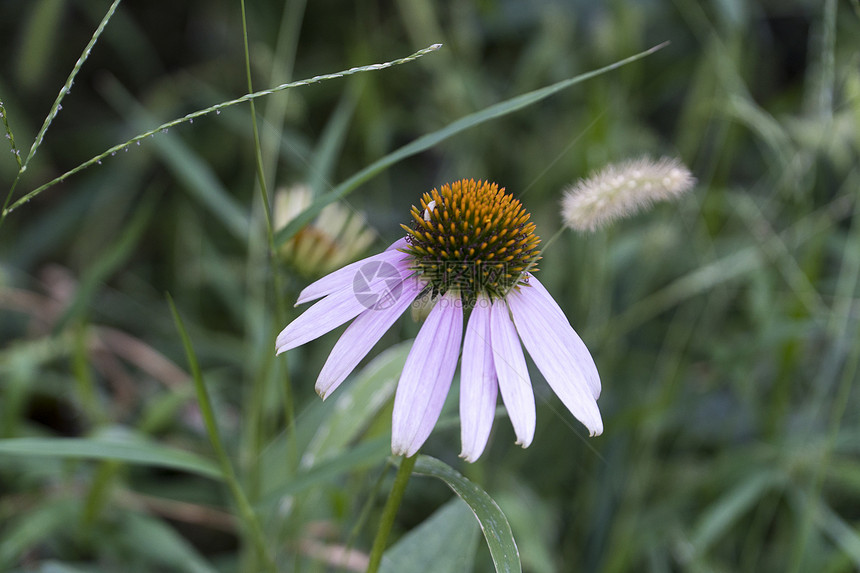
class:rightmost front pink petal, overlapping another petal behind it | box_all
[507,284,603,436]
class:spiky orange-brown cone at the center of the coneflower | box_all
[401,179,540,308]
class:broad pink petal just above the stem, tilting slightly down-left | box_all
[391,293,463,456]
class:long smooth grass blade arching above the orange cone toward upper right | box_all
[275,43,666,246]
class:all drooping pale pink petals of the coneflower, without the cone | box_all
[276,239,603,462]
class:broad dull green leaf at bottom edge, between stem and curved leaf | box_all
[379,498,478,573]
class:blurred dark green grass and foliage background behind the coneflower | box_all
[0,0,860,573]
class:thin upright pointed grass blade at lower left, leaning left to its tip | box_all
[167,295,277,573]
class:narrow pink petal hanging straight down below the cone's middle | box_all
[460,296,499,462]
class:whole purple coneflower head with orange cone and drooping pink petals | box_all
[276,180,603,462]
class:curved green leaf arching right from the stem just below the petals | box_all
[413,455,522,573]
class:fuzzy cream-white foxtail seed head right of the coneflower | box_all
[561,157,696,231]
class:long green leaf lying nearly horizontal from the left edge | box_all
[0,438,221,479]
